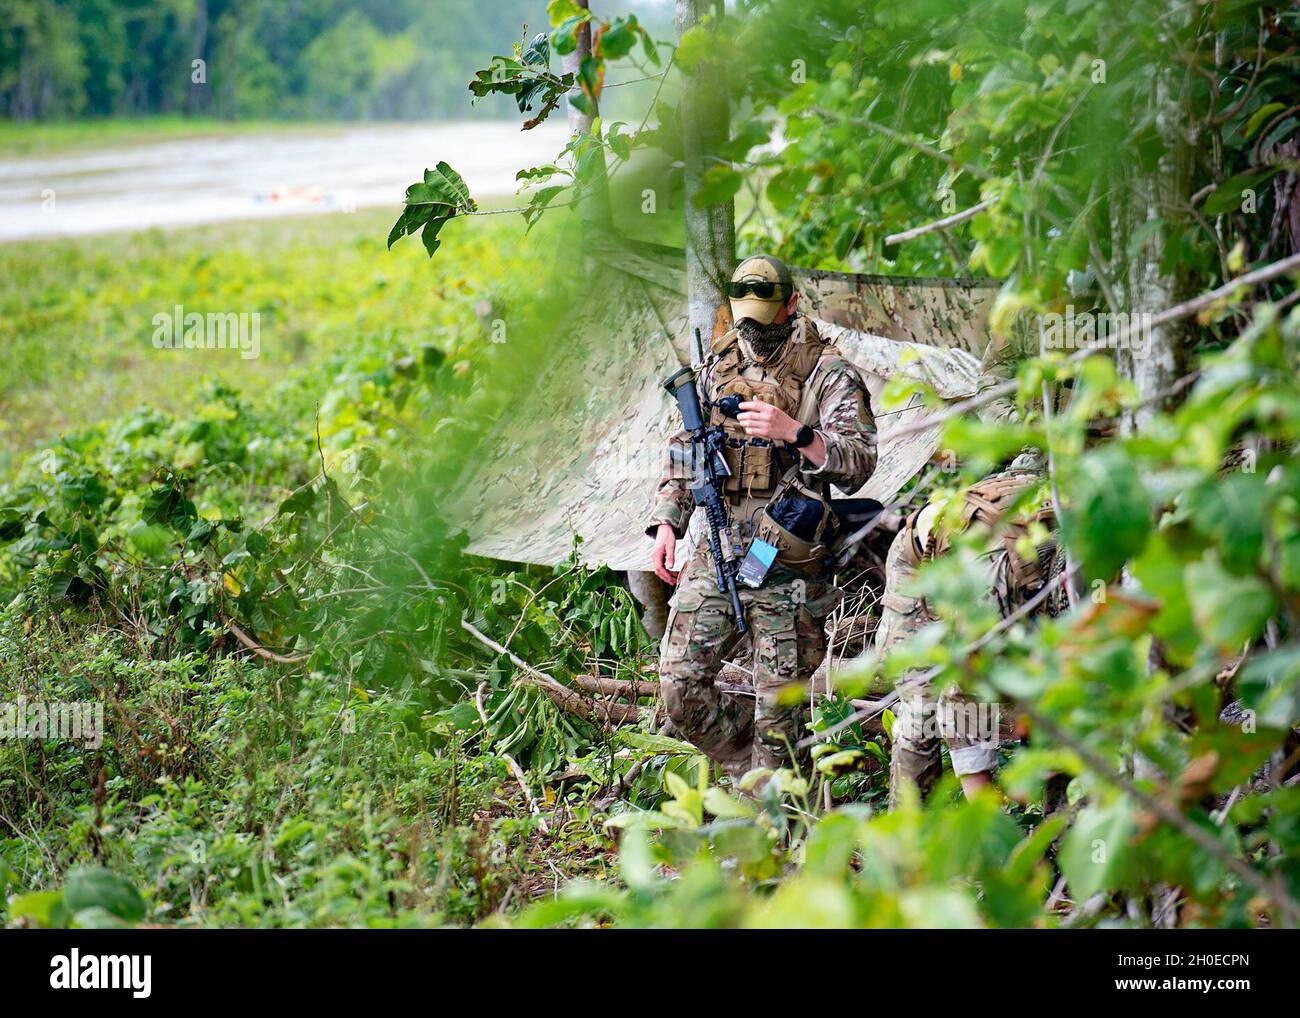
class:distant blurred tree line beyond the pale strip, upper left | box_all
[0,0,660,121]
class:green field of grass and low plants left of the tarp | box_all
[0,187,644,926]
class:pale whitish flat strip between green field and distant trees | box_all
[0,122,568,242]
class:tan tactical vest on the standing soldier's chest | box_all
[709,317,833,502]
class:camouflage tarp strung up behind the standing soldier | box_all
[452,244,996,569]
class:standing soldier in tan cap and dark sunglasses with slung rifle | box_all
[646,255,876,776]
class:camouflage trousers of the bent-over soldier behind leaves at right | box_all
[875,529,998,807]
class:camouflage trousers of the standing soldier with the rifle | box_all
[659,546,827,777]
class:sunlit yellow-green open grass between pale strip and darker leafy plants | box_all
[0,209,520,469]
